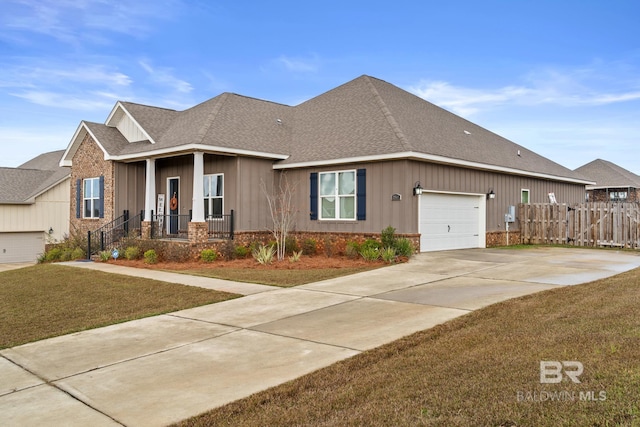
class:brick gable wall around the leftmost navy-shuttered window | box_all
[69,135,115,236]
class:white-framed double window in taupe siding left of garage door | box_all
[319,170,356,219]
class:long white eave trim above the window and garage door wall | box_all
[273,151,595,185]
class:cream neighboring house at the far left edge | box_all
[0,150,71,263]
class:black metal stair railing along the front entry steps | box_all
[87,210,144,259]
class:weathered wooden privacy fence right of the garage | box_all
[518,203,640,248]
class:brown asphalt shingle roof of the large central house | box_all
[66,76,586,180]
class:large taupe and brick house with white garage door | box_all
[61,76,591,251]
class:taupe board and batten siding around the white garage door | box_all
[286,160,585,234]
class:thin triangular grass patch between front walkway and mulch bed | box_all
[175,265,380,288]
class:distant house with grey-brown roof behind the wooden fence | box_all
[576,159,640,202]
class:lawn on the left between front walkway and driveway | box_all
[0,264,238,348]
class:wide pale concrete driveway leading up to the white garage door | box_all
[0,248,640,426]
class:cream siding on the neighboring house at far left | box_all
[0,179,70,242]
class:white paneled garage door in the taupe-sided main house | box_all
[420,193,486,252]
